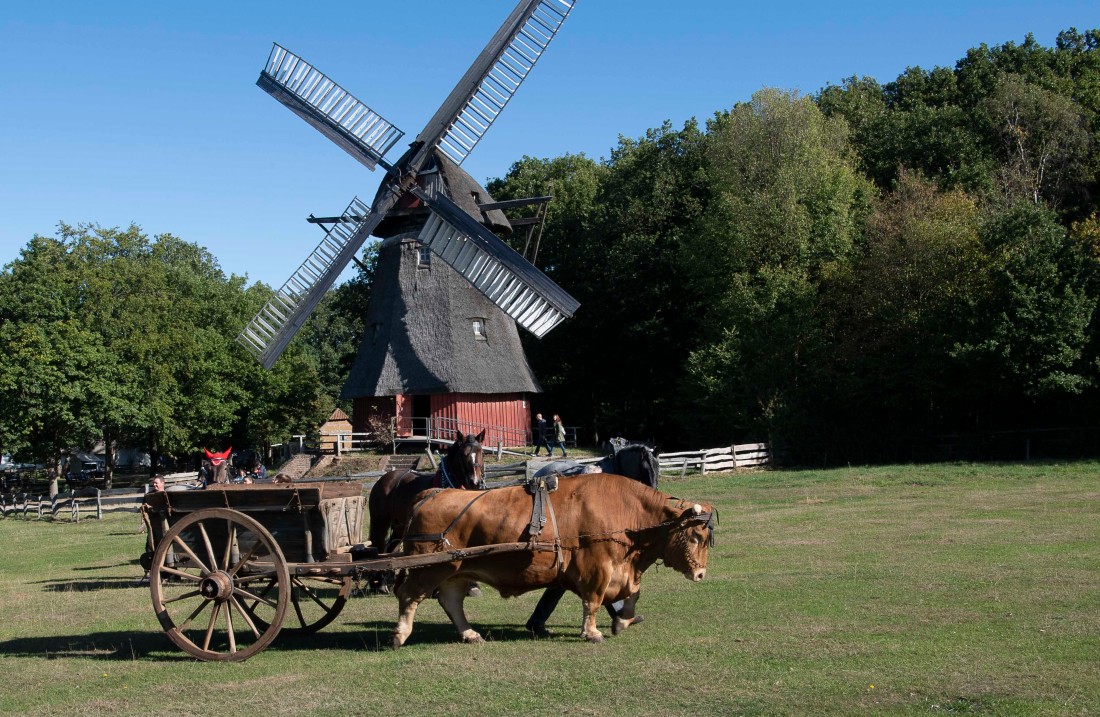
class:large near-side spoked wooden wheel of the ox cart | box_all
[149,508,290,662]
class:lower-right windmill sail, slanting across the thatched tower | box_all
[413,189,580,338]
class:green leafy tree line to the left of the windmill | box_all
[0,224,331,492]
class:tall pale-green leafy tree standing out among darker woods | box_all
[682,90,872,442]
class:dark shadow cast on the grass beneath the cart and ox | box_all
[0,621,550,662]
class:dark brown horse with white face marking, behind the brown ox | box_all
[367,431,485,552]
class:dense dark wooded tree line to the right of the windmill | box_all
[490,31,1100,462]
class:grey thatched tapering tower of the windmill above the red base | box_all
[341,234,542,398]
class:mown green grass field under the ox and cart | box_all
[0,463,1100,717]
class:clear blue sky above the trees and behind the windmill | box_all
[0,0,1100,286]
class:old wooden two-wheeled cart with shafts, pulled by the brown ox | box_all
[142,481,549,662]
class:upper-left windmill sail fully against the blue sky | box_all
[256,44,405,169]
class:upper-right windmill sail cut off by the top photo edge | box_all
[414,0,575,166]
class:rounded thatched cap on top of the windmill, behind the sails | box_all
[374,150,512,239]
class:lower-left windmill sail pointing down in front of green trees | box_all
[237,197,382,368]
